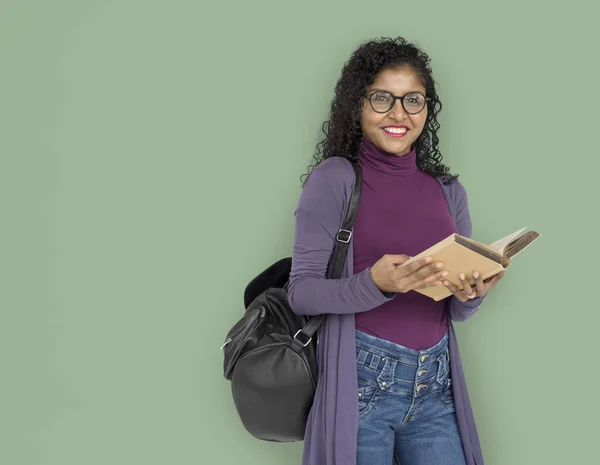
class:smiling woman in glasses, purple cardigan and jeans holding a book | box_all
[289,38,502,465]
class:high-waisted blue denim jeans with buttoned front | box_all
[356,330,466,465]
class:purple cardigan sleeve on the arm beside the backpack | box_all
[288,158,393,315]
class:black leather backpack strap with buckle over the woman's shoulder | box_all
[294,162,362,347]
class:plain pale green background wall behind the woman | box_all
[0,0,600,465]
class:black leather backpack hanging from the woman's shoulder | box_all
[221,163,362,442]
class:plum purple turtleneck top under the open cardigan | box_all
[353,140,458,350]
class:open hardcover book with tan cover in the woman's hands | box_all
[400,228,540,301]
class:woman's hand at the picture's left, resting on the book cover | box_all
[371,255,448,294]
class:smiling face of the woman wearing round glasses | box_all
[360,66,427,156]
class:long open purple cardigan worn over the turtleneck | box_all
[288,157,483,465]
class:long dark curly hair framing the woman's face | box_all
[303,37,458,182]
